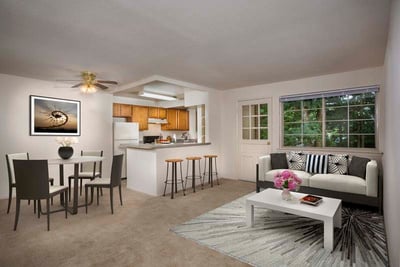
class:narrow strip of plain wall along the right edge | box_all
[383,0,400,266]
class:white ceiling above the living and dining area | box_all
[0,0,390,89]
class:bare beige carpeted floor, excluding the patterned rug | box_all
[0,179,255,267]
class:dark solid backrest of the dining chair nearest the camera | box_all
[13,160,49,199]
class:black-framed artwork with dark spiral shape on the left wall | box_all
[30,95,81,136]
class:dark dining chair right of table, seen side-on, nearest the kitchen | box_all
[85,155,123,214]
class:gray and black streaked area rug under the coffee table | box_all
[171,193,389,266]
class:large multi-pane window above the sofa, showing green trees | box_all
[281,86,378,148]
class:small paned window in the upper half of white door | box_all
[242,103,268,140]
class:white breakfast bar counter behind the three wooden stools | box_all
[124,143,217,196]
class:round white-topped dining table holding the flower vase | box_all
[47,156,104,214]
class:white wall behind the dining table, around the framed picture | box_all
[0,74,113,200]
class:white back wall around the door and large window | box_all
[219,67,384,179]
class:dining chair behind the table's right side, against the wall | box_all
[68,150,103,200]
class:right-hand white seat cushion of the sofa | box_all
[309,173,366,195]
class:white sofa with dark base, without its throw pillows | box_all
[256,155,382,213]
